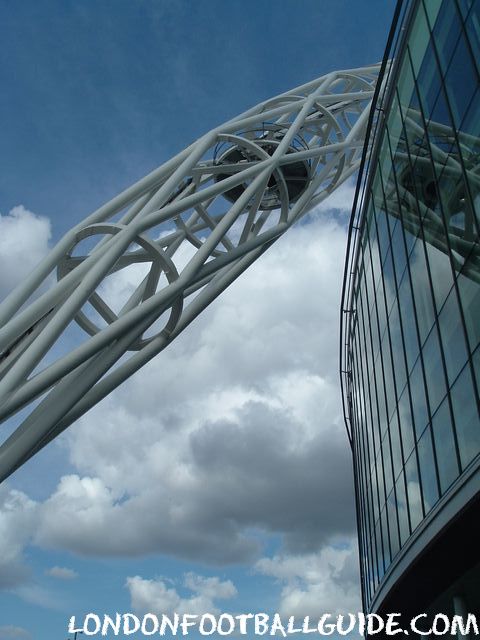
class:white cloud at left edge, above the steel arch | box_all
[0,205,51,300]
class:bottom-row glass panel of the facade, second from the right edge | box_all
[432,399,459,494]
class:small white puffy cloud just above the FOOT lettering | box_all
[126,573,237,615]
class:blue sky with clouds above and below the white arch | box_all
[0,0,394,640]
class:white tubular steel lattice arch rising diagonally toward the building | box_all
[0,65,380,480]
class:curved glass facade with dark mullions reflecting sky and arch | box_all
[342,0,480,607]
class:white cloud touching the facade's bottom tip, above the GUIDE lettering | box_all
[255,539,362,618]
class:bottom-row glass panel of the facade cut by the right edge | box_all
[452,366,480,469]
